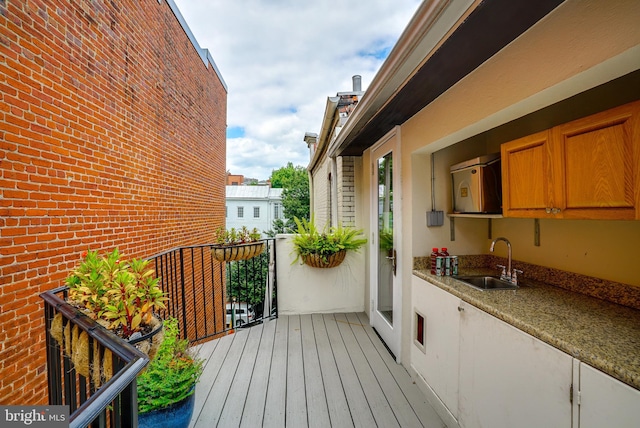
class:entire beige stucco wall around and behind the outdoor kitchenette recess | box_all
[390,0,640,364]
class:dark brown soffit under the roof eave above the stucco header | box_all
[335,0,564,156]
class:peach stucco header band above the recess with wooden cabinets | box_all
[402,0,640,153]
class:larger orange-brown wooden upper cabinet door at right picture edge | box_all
[552,103,640,220]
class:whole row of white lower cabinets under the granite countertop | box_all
[411,277,640,428]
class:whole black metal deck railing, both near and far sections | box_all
[40,239,278,428]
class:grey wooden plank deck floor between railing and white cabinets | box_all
[191,314,445,428]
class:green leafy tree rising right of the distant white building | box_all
[267,162,310,234]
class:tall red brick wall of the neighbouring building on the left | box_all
[0,0,227,404]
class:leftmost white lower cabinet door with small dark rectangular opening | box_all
[411,276,460,418]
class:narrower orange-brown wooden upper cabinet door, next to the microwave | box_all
[501,131,554,217]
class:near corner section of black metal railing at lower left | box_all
[40,287,149,428]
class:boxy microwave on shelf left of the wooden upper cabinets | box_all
[451,153,502,214]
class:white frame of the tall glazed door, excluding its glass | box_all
[369,126,403,363]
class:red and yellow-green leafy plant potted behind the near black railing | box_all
[66,248,168,339]
